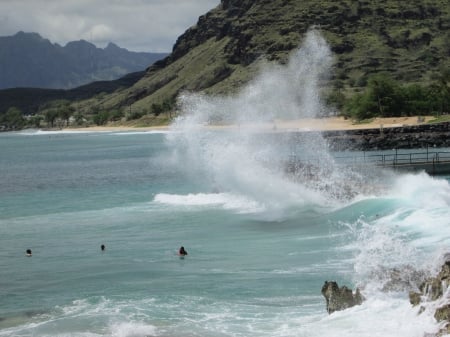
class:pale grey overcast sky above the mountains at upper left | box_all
[0,0,220,52]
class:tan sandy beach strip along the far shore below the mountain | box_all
[67,116,433,131]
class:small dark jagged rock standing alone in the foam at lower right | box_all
[322,281,364,314]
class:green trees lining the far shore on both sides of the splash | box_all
[0,70,450,130]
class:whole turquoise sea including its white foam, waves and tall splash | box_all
[0,31,450,337]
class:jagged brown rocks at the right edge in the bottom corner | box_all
[409,256,450,336]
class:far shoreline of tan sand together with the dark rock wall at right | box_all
[5,116,450,151]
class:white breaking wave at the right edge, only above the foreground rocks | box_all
[342,172,450,293]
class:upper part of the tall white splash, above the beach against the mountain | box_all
[175,30,332,124]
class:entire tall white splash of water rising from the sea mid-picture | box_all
[168,30,372,213]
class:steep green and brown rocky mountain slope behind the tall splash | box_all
[93,0,450,112]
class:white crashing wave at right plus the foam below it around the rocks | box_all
[315,172,450,337]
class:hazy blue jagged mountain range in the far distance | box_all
[0,32,167,89]
